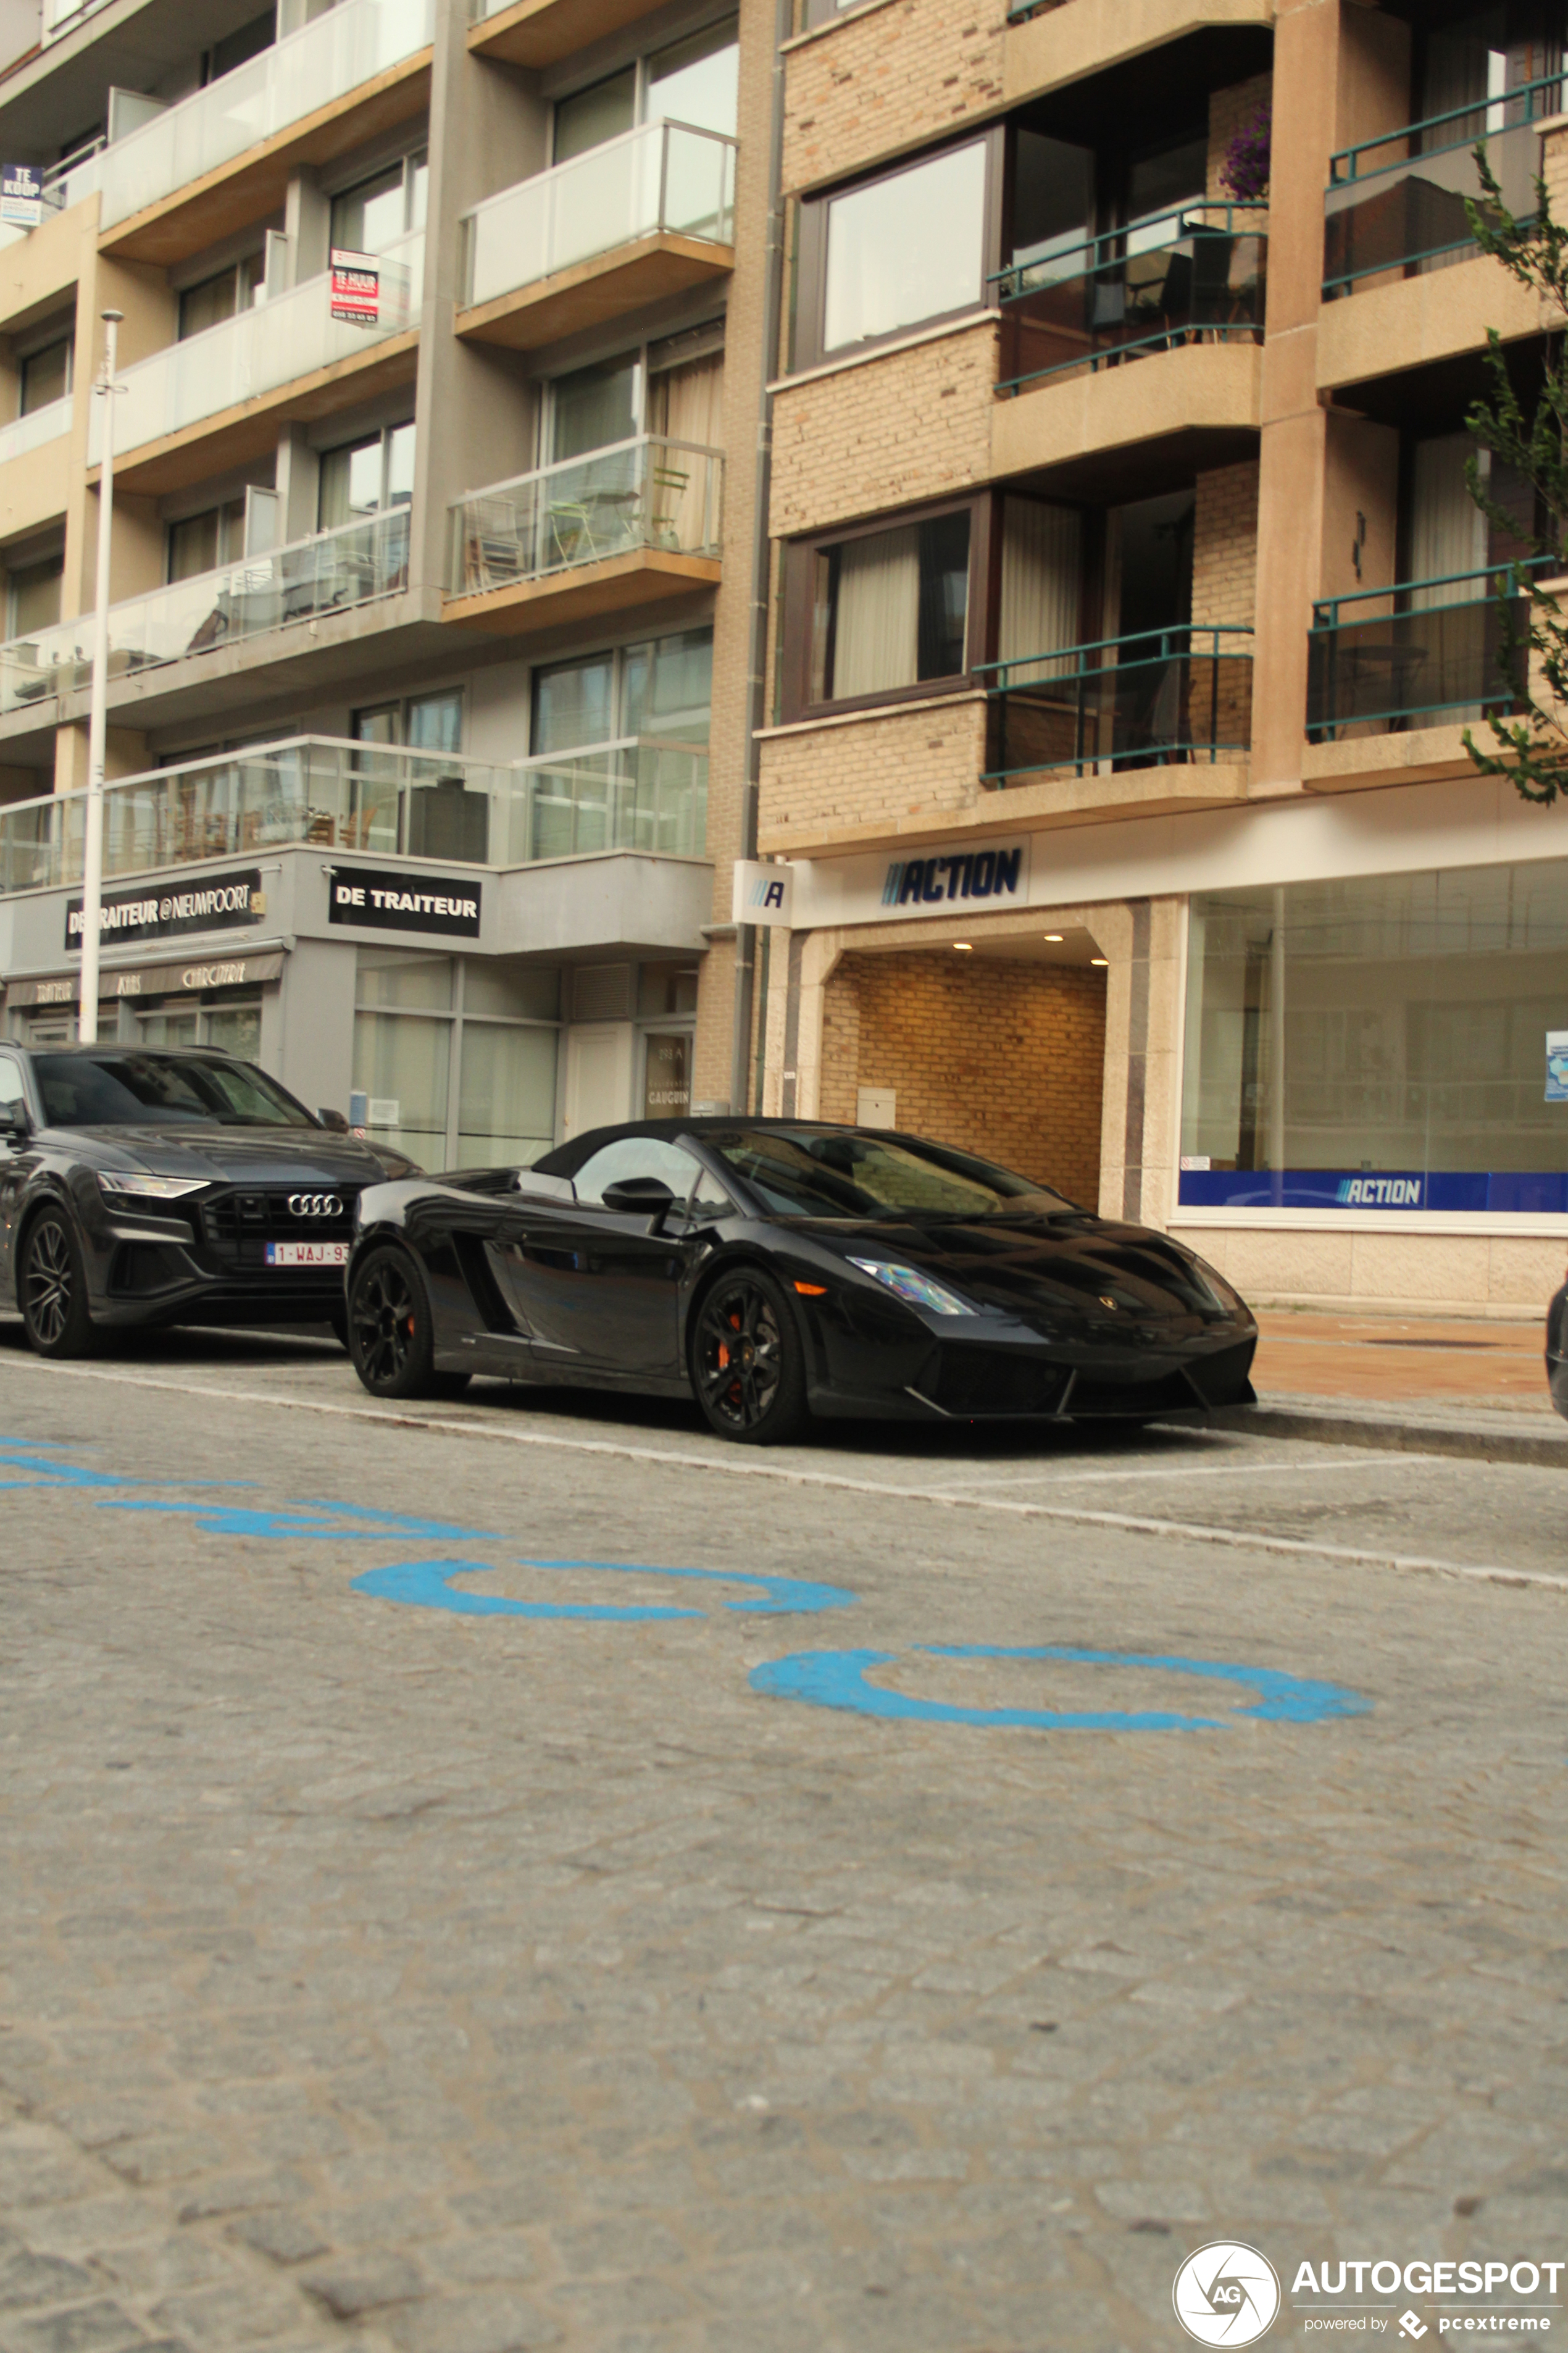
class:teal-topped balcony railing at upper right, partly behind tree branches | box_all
[1323,73,1568,299]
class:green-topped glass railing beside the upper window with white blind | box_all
[993,205,1269,393]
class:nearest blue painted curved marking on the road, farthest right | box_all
[751,1642,1372,1732]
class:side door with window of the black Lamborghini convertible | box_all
[497,1137,699,1381]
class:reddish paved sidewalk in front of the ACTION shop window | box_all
[1224,1308,1568,1471]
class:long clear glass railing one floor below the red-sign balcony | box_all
[0,506,407,713]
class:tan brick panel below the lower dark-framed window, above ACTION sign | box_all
[761,694,986,854]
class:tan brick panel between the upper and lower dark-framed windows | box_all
[770,320,998,539]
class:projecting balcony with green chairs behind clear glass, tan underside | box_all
[443,440,723,635]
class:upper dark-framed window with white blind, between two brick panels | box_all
[796,132,1001,367]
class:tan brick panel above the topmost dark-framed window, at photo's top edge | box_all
[784,0,1007,193]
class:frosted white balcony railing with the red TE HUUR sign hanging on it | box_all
[99,228,423,464]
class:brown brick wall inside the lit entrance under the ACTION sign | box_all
[822,948,1106,1210]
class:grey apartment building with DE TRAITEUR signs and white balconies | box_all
[0,0,775,1167]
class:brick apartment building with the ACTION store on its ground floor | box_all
[751,0,1568,1311]
